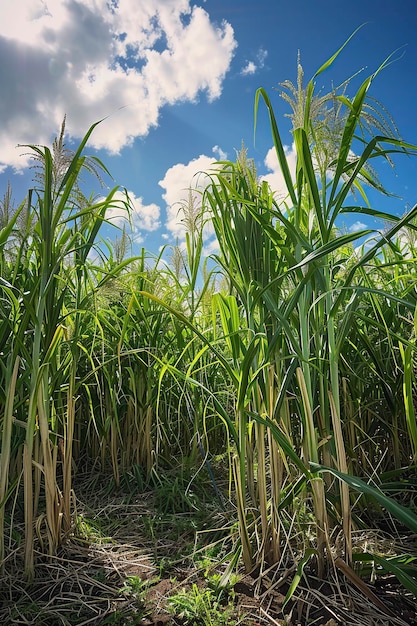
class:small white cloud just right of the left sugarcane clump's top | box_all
[106,191,161,243]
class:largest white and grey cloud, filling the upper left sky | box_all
[0,0,236,171]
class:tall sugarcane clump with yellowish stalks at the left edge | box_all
[0,117,132,578]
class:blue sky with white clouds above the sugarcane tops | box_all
[0,0,417,251]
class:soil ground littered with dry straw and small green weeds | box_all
[0,466,417,626]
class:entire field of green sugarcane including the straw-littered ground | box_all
[0,40,417,626]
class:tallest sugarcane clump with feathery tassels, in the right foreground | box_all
[206,34,417,575]
